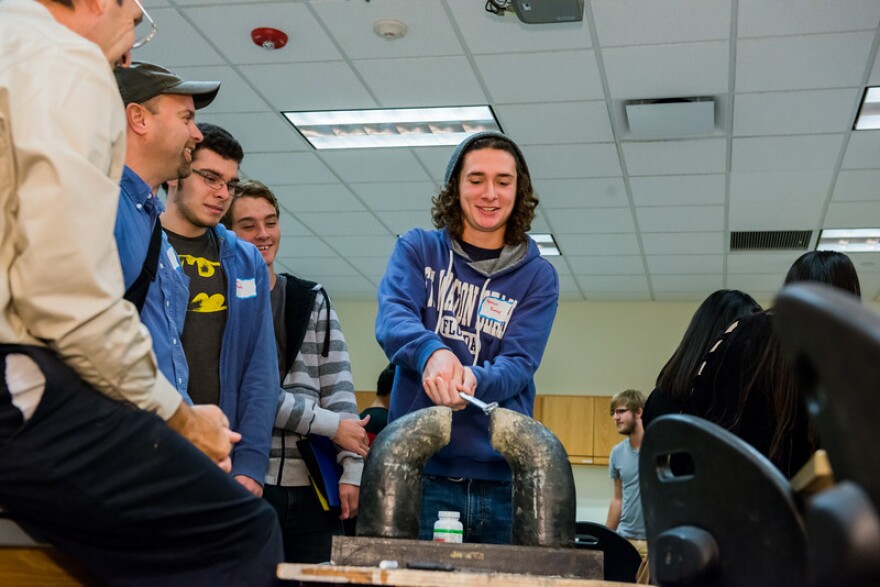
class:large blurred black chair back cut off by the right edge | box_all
[775,283,880,585]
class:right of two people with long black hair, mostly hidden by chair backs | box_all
[684,251,861,477]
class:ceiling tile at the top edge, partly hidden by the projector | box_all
[446,0,590,55]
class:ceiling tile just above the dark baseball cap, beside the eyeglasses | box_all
[131,5,226,70]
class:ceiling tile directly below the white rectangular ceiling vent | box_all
[623,139,727,175]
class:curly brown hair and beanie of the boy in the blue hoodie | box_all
[431,134,538,245]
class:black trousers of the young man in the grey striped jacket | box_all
[263,485,342,563]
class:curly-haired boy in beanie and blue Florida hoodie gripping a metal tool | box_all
[376,132,559,544]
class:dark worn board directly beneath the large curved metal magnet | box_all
[330,536,605,579]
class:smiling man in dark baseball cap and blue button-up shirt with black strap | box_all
[114,62,220,403]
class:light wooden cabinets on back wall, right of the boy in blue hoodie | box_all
[535,395,623,465]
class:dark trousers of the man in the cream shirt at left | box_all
[0,345,281,587]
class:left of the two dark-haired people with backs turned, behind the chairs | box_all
[642,289,761,429]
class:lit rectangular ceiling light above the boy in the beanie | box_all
[282,106,501,149]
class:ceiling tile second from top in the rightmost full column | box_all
[736,33,874,92]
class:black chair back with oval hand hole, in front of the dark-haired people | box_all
[639,414,806,587]
